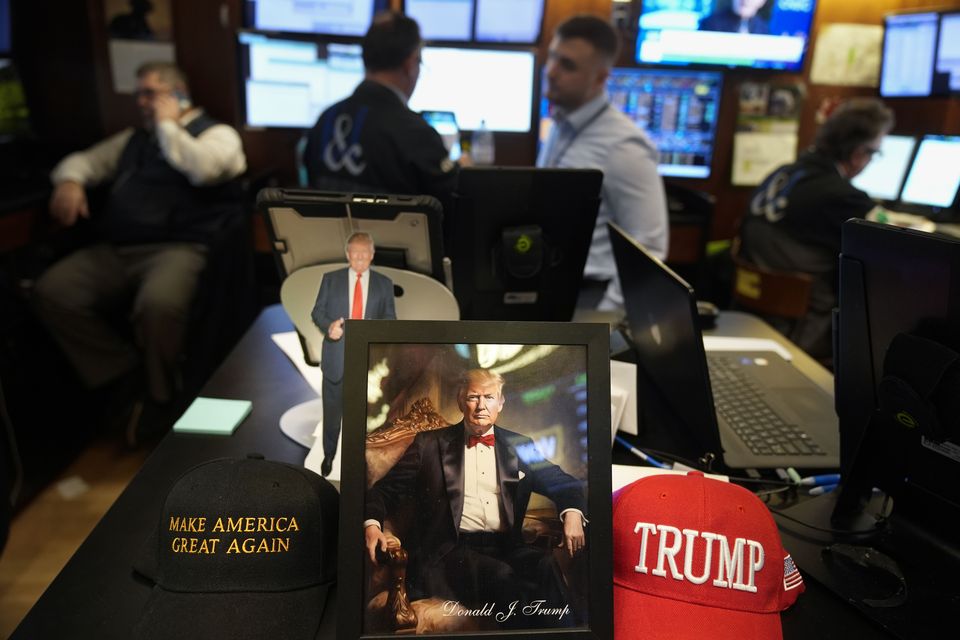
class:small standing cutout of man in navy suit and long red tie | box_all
[311,231,397,476]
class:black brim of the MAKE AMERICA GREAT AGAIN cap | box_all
[133,584,331,640]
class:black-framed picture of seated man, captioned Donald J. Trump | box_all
[337,320,613,640]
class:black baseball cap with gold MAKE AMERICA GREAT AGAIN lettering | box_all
[134,457,339,640]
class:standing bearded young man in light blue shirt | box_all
[537,15,669,310]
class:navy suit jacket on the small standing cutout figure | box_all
[310,267,397,383]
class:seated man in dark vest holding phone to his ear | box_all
[35,62,246,448]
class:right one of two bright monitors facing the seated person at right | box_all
[900,135,960,210]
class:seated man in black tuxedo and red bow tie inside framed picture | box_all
[364,369,587,628]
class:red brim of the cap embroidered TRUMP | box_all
[613,583,783,640]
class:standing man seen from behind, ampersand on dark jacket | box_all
[303,12,457,204]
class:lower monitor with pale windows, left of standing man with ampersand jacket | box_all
[238,32,364,129]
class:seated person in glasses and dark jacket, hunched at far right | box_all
[739,98,894,358]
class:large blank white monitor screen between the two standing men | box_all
[409,47,536,133]
